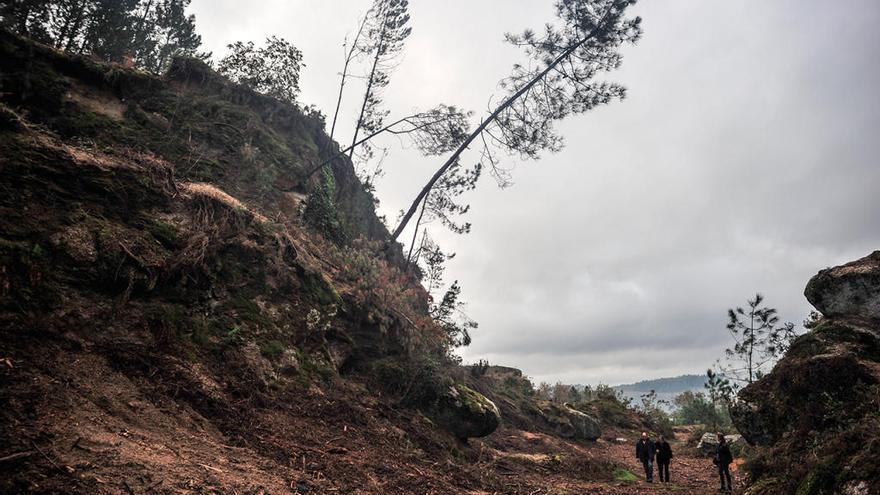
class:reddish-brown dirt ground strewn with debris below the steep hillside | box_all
[0,339,744,495]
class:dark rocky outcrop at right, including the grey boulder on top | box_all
[731,251,880,495]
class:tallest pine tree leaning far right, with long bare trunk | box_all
[391,0,642,242]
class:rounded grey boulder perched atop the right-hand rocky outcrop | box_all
[804,251,880,320]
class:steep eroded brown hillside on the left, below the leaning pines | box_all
[0,29,668,494]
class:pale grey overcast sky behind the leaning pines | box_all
[191,0,880,384]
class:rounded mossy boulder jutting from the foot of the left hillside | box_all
[432,383,501,440]
